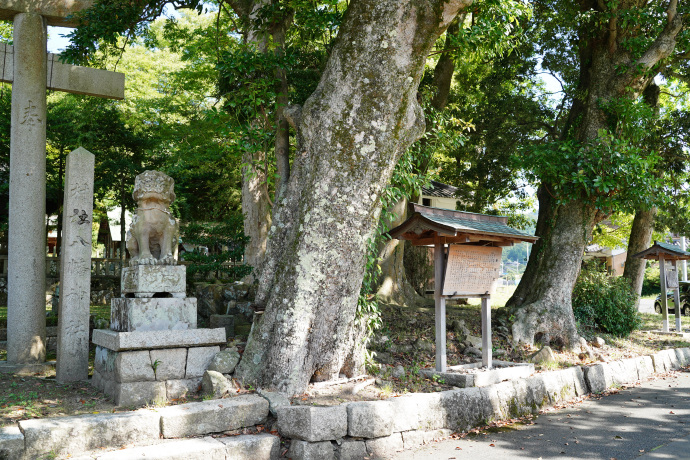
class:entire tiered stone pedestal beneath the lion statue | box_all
[92,265,227,406]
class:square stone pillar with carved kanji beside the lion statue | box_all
[56,147,94,382]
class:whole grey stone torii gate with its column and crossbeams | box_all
[0,0,124,371]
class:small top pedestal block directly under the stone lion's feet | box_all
[122,265,187,297]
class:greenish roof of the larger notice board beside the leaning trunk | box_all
[388,203,538,245]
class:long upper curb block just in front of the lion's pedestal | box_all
[158,395,268,438]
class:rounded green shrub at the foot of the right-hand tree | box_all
[573,270,642,337]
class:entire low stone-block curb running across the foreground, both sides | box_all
[0,348,690,460]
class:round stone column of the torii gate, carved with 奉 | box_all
[7,13,47,363]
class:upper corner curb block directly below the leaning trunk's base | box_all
[276,403,347,442]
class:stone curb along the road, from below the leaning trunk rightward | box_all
[277,348,690,460]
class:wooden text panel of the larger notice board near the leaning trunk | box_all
[442,244,501,296]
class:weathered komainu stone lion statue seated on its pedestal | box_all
[127,171,179,266]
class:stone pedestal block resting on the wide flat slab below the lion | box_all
[110,297,196,332]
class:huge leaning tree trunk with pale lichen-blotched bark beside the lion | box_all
[237,0,469,394]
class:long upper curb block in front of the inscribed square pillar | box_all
[19,410,160,458]
